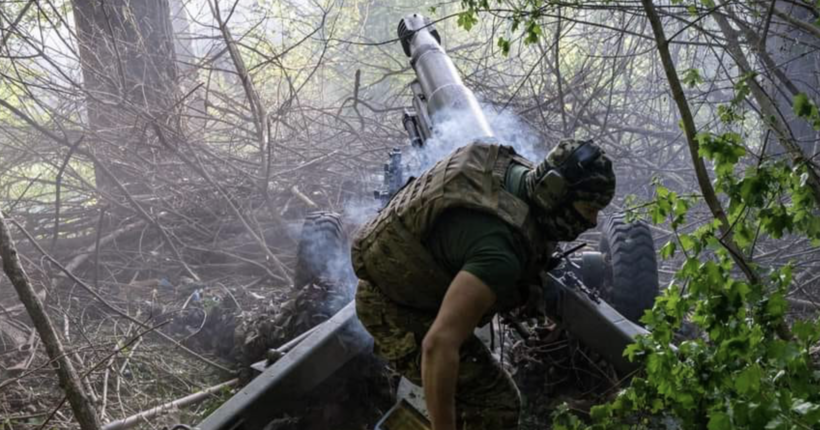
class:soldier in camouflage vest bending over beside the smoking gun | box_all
[352,140,615,430]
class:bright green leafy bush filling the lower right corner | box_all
[554,103,820,430]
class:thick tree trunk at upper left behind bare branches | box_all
[72,0,178,194]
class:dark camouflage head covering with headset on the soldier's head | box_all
[525,140,615,241]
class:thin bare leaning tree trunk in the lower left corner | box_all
[0,212,102,430]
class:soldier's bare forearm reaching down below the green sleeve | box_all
[421,271,496,430]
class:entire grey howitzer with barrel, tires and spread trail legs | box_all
[191,14,658,430]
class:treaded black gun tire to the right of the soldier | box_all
[599,215,660,323]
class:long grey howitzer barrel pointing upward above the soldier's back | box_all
[398,14,493,139]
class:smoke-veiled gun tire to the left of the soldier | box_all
[293,211,353,289]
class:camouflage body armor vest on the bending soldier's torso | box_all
[352,143,554,315]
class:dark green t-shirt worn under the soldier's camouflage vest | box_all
[425,164,528,301]
